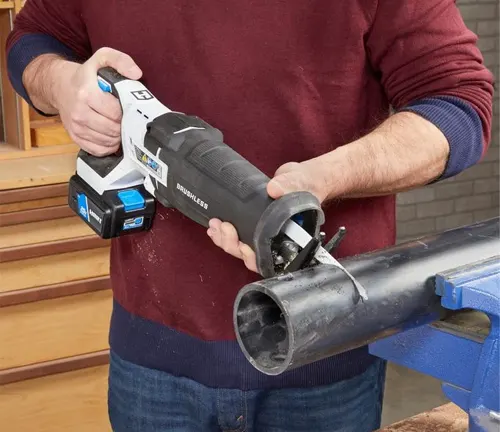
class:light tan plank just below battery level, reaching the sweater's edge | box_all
[0,247,109,292]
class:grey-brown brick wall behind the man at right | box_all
[397,0,500,241]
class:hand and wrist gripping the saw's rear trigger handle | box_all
[23,48,142,156]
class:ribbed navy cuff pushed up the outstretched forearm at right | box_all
[399,96,483,181]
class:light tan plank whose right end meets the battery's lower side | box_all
[0,216,94,246]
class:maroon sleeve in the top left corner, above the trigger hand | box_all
[6,0,91,59]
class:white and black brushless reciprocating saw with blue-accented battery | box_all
[68,68,368,290]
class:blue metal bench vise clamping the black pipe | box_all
[369,255,500,432]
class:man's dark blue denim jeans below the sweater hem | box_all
[108,353,385,432]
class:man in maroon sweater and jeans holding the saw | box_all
[7,0,493,432]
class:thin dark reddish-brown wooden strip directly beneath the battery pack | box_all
[0,235,111,263]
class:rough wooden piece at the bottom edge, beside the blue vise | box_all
[380,403,469,432]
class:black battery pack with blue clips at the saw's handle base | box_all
[68,175,155,239]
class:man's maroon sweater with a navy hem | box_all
[7,0,492,388]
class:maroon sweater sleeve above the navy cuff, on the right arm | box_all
[366,0,493,153]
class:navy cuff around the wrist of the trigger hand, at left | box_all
[7,33,78,116]
